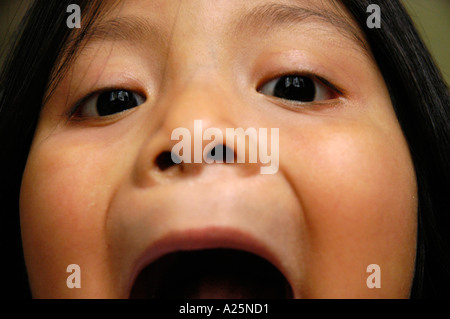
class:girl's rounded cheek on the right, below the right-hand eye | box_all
[280,127,417,298]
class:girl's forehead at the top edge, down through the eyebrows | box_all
[73,0,369,53]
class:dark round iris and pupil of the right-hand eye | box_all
[274,75,316,102]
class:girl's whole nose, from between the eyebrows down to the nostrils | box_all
[130,2,272,187]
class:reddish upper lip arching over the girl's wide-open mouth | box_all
[127,226,293,296]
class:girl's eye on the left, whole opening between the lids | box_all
[73,89,145,118]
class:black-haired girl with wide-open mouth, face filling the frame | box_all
[0,0,450,298]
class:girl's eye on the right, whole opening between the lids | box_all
[258,75,337,103]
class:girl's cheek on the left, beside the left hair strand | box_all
[20,141,124,298]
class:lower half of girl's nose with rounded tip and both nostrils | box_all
[134,78,259,186]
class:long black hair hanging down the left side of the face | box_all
[0,0,106,299]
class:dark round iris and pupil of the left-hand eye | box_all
[97,91,137,116]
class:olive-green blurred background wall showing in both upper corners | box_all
[0,0,450,83]
